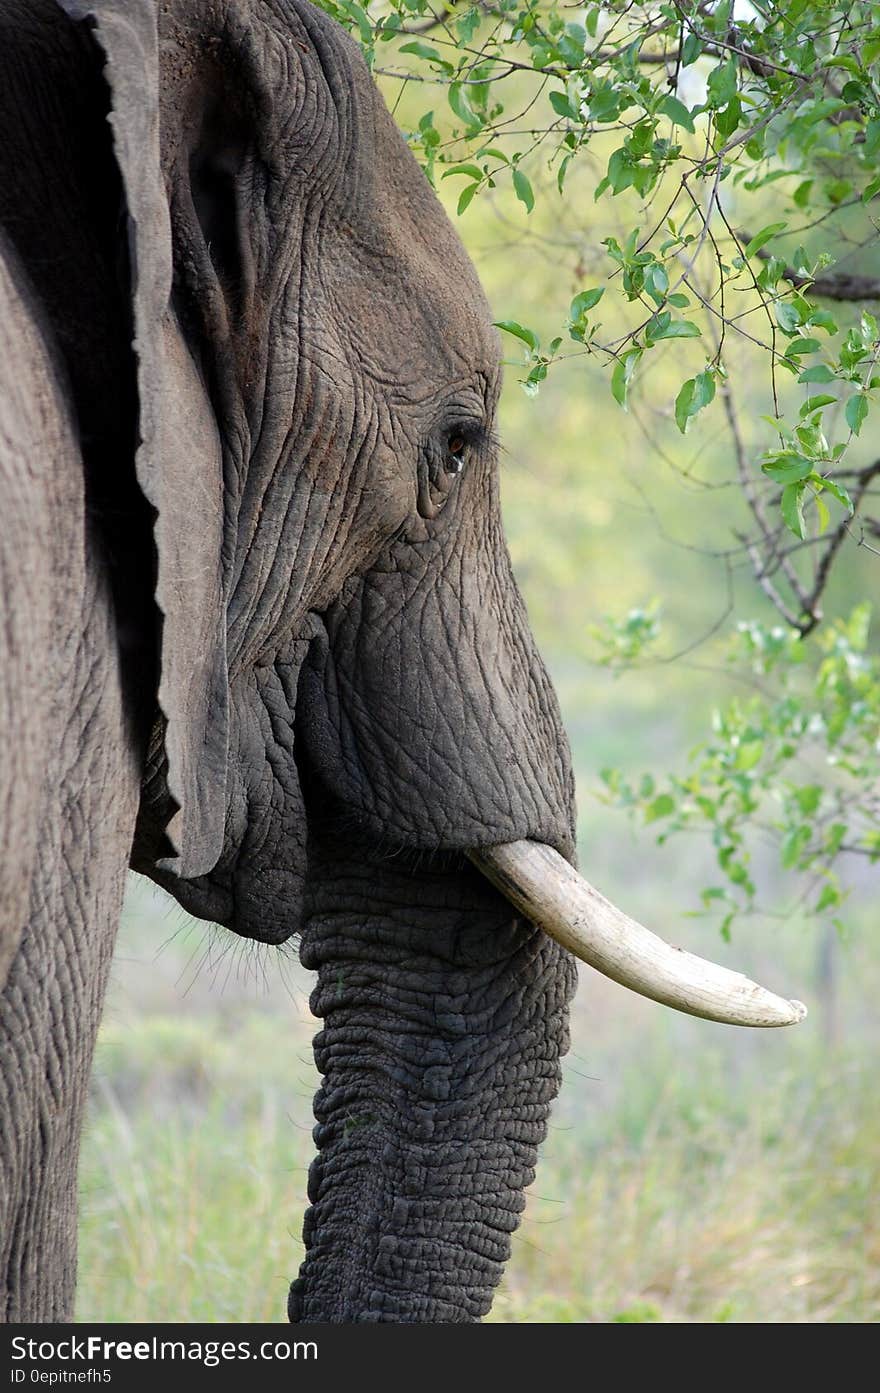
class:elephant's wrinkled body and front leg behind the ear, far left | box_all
[0,238,143,1321]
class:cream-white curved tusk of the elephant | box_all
[468,841,806,1025]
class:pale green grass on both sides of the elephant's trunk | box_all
[77,874,880,1322]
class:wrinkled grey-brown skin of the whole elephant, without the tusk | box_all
[0,0,574,1322]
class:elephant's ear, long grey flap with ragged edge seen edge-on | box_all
[58,0,228,879]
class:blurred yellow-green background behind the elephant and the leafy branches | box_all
[77,141,880,1322]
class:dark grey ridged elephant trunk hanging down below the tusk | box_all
[290,835,575,1322]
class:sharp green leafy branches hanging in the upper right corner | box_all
[322,0,880,540]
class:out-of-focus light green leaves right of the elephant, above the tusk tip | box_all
[602,605,880,937]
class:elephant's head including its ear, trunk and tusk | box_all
[6,0,796,1321]
